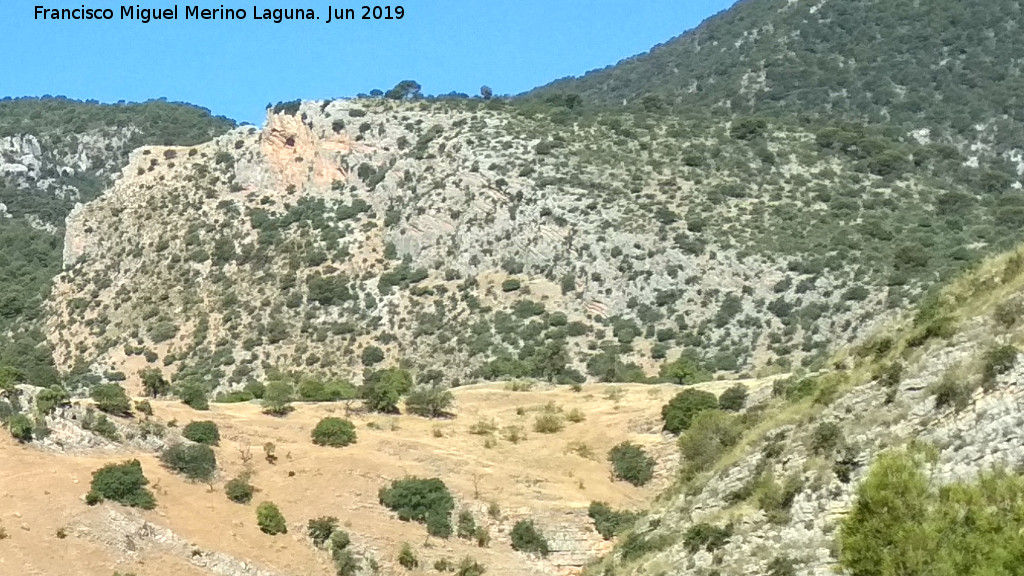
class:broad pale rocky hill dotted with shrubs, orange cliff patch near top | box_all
[49,95,1007,387]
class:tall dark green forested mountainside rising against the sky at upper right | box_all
[534,0,1024,154]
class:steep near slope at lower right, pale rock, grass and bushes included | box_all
[590,242,1024,576]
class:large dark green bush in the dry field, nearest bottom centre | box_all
[378,478,455,538]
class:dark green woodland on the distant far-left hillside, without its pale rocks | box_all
[0,96,234,386]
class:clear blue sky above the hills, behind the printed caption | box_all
[0,0,732,123]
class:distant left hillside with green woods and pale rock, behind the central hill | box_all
[0,97,234,383]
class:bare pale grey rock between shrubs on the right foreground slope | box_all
[610,309,1024,576]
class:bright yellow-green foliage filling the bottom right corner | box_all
[839,453,1024,576]
